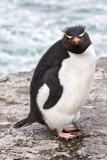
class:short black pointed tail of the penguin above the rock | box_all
[13,117,33,129]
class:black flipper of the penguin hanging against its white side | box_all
[43,66,63,109]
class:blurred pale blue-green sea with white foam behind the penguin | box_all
[0,0,107,77]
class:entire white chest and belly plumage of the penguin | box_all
[36,45,95,129]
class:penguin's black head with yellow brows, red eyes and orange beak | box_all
[62,25,91,54]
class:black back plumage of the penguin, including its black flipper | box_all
[29,40,69,124]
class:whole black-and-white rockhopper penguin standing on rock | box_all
[14,25,96,140]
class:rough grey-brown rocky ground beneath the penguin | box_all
[0,58,107,160]
